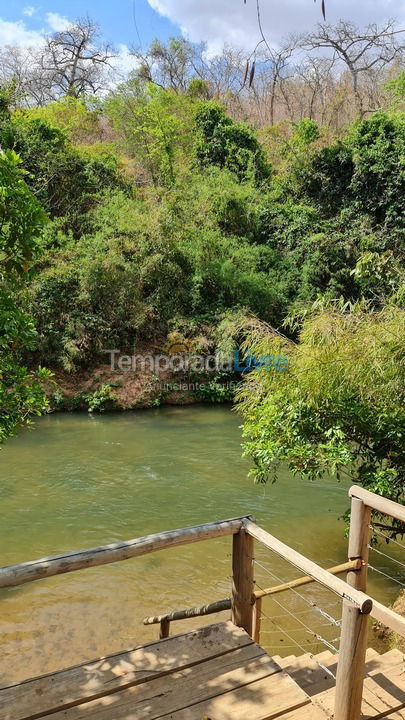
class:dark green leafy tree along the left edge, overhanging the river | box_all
[0,151,50,442]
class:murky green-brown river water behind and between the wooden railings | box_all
[0,407,400,683]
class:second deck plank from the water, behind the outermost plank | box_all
[42,643,282,720]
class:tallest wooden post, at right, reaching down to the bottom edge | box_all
[334,497,371,720]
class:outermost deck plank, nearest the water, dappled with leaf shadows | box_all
[0,621,252,720]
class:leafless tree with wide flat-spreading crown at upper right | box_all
[302,20,404,117]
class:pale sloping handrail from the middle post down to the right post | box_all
[243,520,373,615]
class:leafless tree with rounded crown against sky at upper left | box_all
[38,17,115,99]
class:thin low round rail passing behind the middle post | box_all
[143,560,361,625]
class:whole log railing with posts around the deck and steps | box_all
[0,487,405,720]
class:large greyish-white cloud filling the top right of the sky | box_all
[148,0,405,53]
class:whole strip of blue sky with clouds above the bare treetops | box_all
[0,0,405,61]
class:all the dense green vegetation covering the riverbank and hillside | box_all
[0,29,405,512]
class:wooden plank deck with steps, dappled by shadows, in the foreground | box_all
[0,622,405,720]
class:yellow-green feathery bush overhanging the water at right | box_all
[234,300,405,516]
